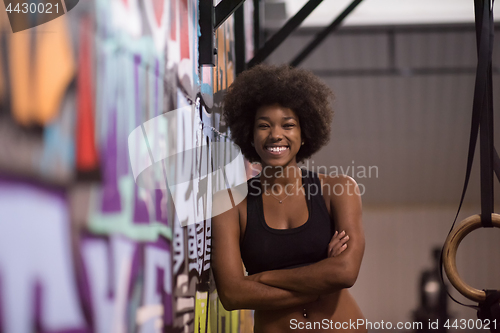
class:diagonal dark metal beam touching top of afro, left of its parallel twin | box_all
[247,0,323,68]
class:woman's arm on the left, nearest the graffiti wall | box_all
[212,191,318,310]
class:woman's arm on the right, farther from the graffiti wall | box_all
[250,176,365,295]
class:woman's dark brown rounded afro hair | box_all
[223,65,333,162]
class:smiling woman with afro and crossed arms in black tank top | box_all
[212,65,366,333]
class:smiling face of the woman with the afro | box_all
[253,104,302,167]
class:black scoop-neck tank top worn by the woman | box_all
[240,169,335,274]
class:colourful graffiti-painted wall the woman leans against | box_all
[0,0,253,333]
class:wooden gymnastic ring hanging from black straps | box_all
[443,214,500,302]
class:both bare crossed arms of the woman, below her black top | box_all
[212,176,365,310]
